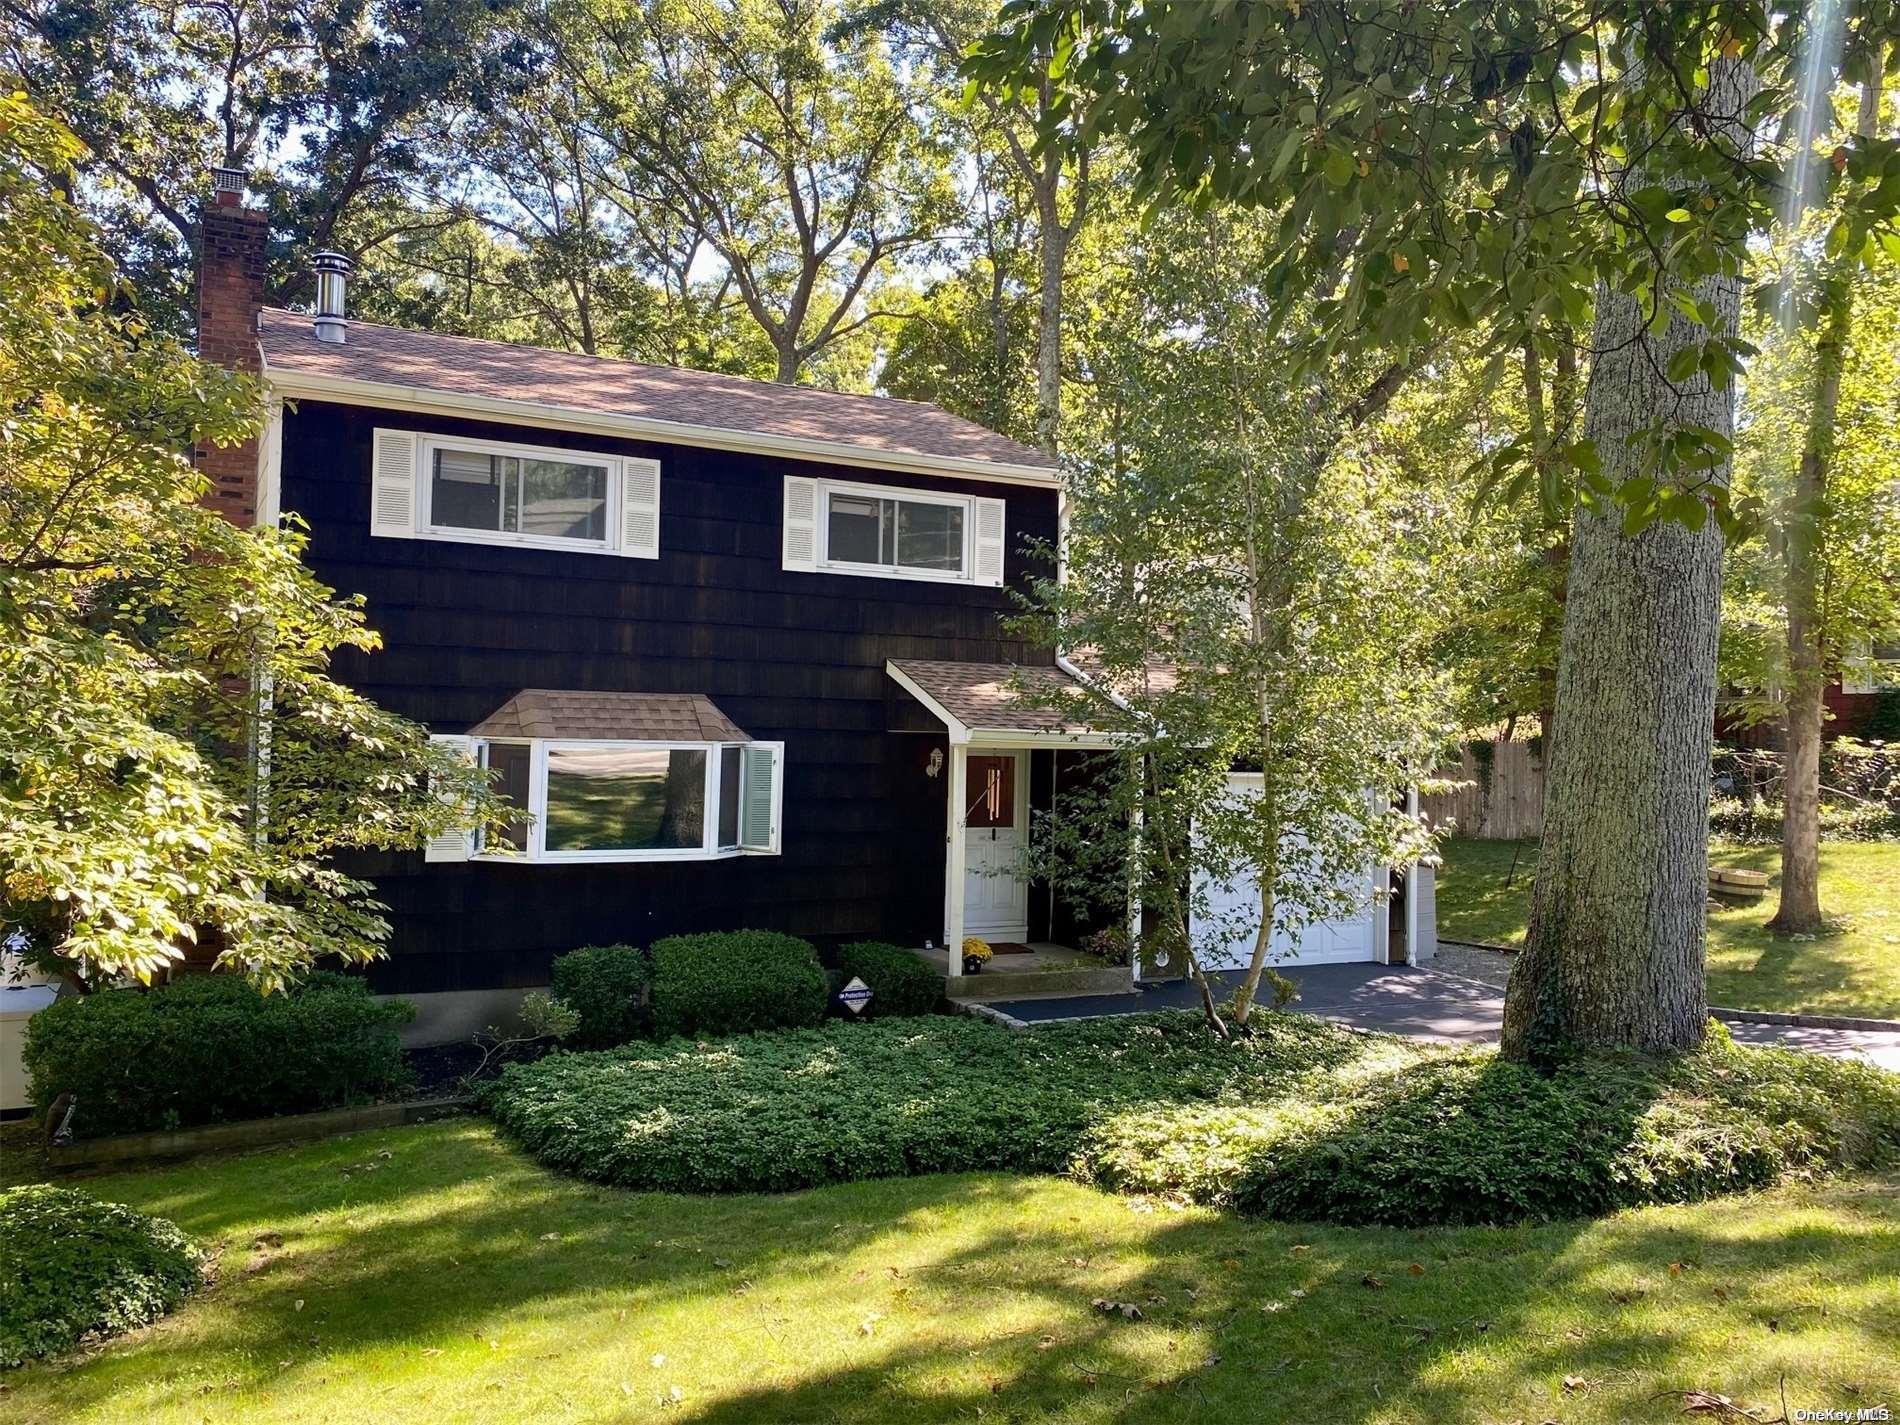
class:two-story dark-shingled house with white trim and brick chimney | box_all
[198,171,1428,1039]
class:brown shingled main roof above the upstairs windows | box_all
[258,308,1055,475]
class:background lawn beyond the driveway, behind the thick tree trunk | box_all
[1438,840,1900,1018]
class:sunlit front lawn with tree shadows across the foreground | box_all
[0,1119,1900,1425]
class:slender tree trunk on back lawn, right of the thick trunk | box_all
[1769,290,1849,935]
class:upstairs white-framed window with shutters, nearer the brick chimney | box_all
[371,428,659,559]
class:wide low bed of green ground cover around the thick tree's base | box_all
[486,1015,1900,1226]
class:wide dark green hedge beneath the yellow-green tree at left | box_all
[23,975,416,1138]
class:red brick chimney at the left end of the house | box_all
[192,169,270,526]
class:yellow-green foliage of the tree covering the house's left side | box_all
[0,101,513,986]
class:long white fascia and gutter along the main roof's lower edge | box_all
[264,359,1060,490]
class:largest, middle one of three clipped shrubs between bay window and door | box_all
[650,931,830,1037]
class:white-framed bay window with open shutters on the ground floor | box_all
[428,735,785,865]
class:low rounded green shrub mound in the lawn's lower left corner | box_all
[0,1186,205,1368]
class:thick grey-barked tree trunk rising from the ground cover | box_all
[1503,63,1756,1060]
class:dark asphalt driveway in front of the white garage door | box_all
[990,965,1900,1070]
